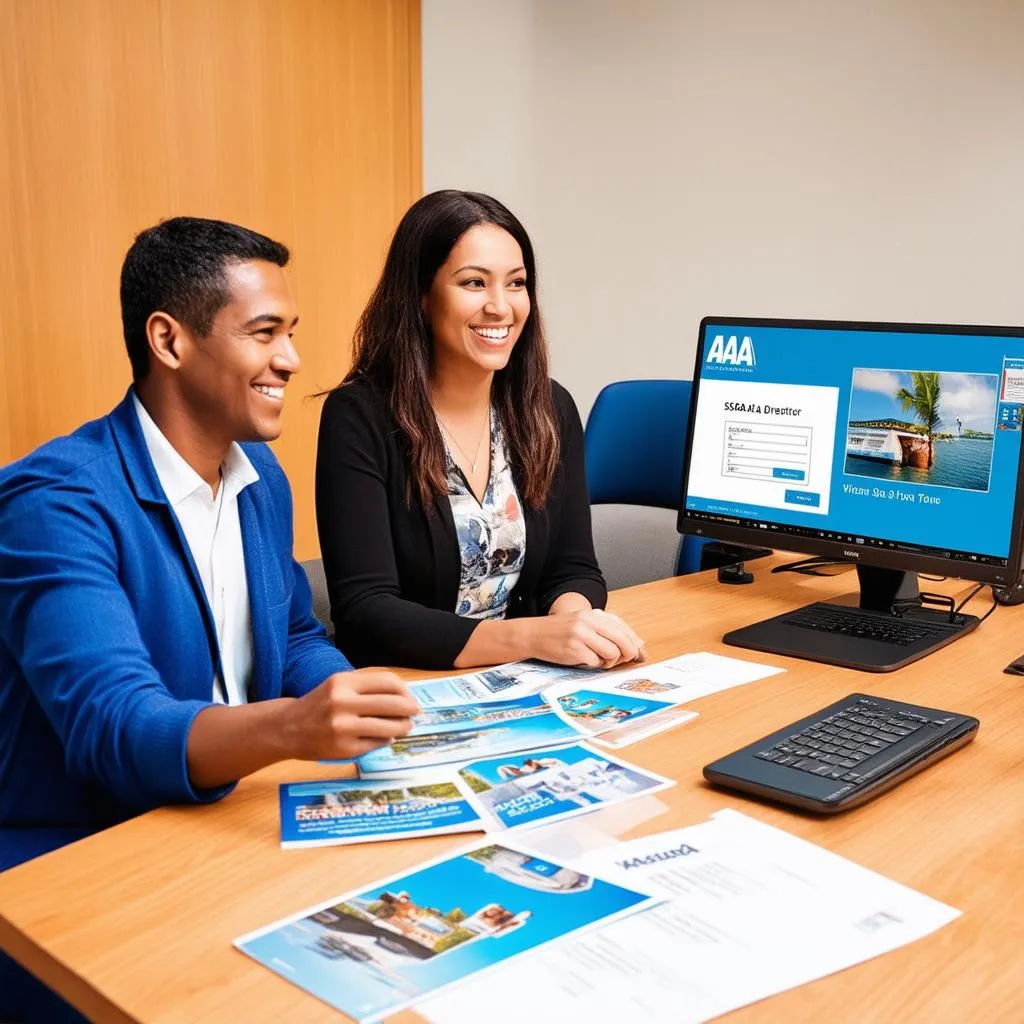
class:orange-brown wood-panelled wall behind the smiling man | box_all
[0,0,421,558]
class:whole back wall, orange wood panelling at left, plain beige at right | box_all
[0,0,1024,558]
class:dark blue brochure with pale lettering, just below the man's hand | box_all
[280,771,490,850]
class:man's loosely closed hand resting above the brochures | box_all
[286,669,420,761]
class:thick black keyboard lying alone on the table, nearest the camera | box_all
[703,693,978,813]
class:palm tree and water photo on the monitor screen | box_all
[845,368,999,490]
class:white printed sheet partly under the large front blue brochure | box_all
[419,810,959,1024]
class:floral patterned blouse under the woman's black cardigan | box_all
[445,410,526,618]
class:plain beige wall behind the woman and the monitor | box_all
[423,0,1024,415]
